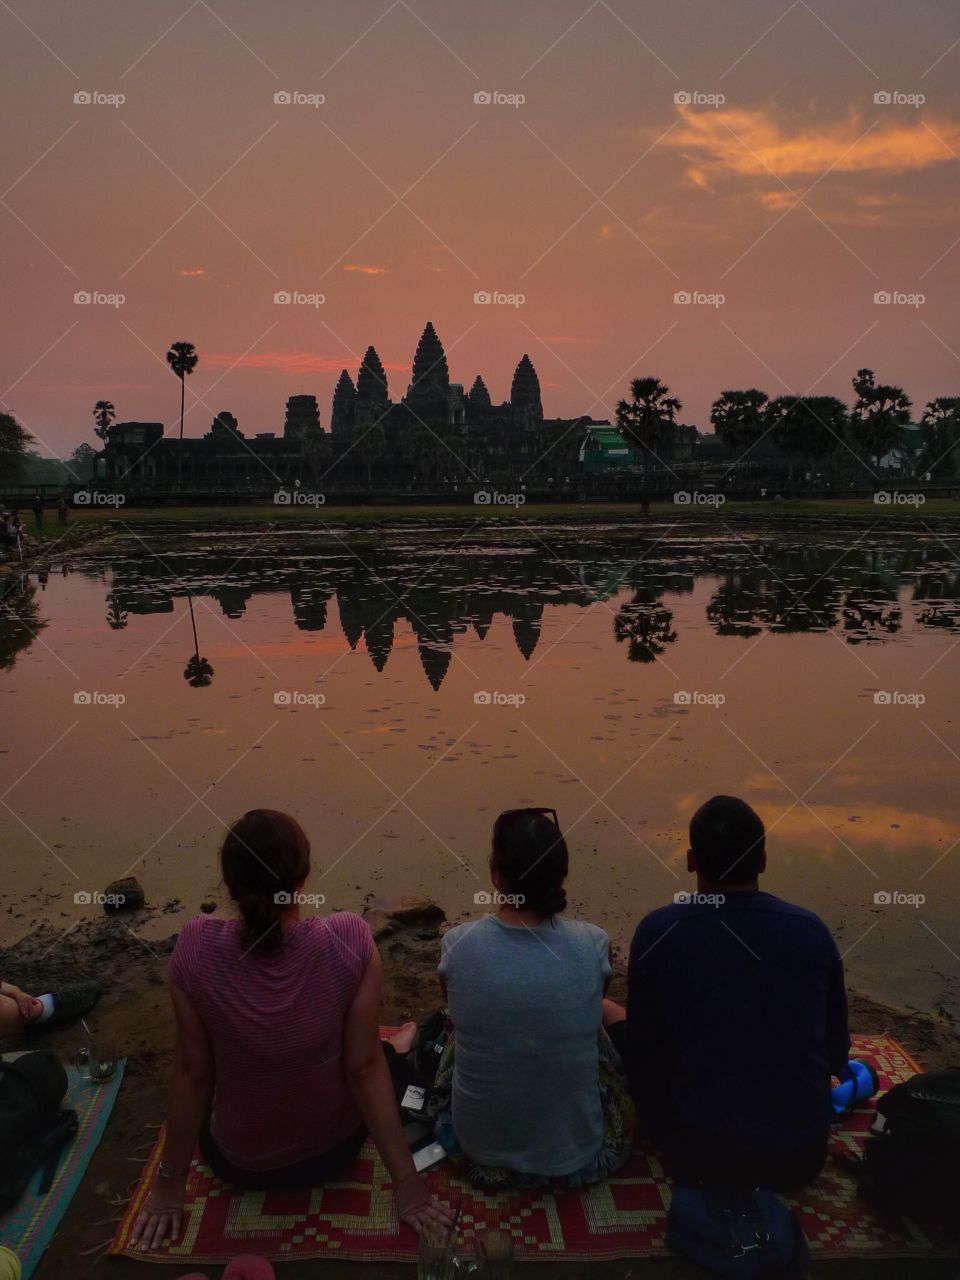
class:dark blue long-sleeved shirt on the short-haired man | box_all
[626,892,850,1152]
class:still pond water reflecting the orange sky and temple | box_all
[0,524,960,1014]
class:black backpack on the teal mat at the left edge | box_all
[0,1050,77,1212]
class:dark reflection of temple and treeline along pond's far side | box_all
[43,540,960,690]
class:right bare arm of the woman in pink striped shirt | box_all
[343,947,451,1231]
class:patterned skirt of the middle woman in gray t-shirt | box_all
[430,1028,636,1192]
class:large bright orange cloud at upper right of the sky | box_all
[664,105,960,189]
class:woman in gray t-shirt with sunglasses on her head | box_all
[439,809,631,1190]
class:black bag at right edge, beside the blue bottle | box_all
[860,1068,960,1226]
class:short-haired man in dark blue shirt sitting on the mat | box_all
[604,796,850,1190]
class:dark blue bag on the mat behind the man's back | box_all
[667,1187,810,1280]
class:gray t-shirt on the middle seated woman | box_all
[439,915,611,1176]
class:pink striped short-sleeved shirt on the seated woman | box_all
[169,911,374,1170]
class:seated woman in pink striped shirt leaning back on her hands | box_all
[132,809,449,1249]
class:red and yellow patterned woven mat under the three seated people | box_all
[110,1036,952,1263]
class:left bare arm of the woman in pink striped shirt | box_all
[131,983,214,1249]
